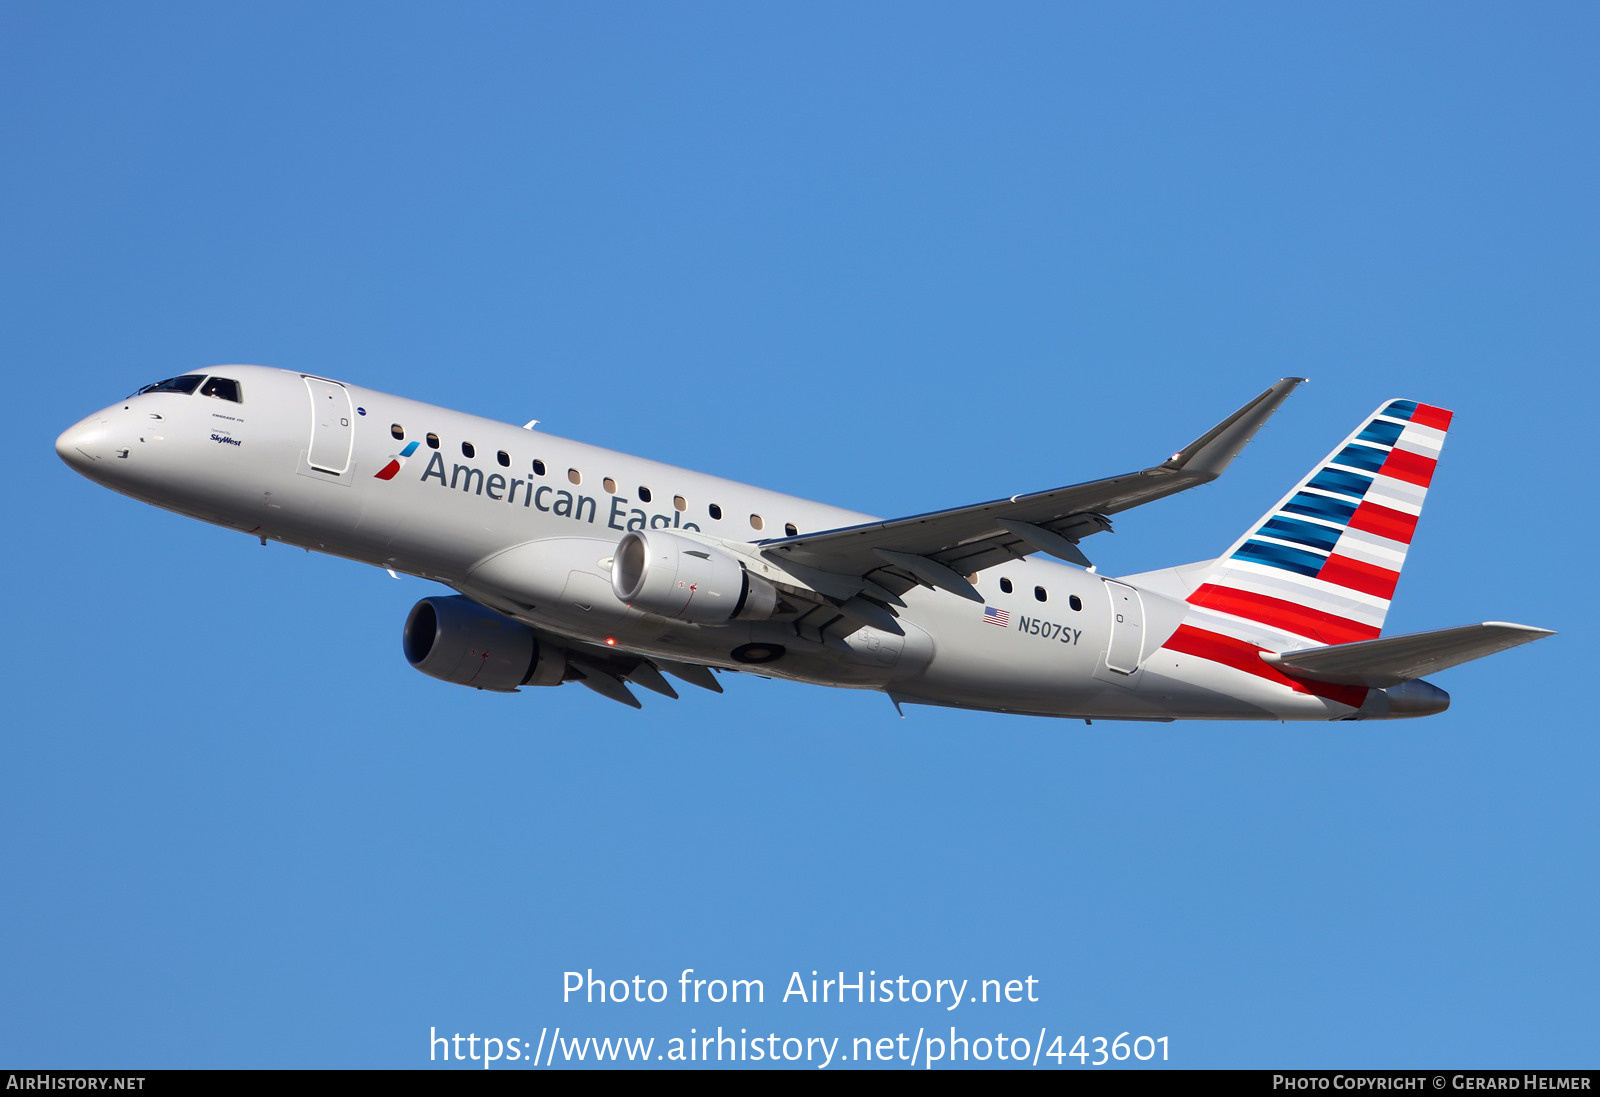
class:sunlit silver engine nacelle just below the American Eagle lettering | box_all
[611,529,778,625]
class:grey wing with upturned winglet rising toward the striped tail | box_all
[760,377,1304,600]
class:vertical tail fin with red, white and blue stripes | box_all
[1186,400,1450,651]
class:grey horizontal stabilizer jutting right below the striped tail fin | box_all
[1261,620,1555,689]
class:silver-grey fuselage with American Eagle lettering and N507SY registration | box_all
[58,366,1427,720]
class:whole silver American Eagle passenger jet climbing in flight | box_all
[56,366,1554,721]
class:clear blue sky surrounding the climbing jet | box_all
[0,3,1600,1070]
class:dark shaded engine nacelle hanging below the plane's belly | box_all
[402,596,566,692]
